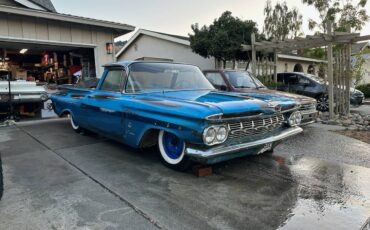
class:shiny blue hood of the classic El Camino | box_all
[130,90,275,118]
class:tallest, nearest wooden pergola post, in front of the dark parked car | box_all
[327,21,334,119]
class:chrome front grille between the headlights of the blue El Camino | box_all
[229,114,284,138]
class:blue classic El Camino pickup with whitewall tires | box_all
[51,61,302,170]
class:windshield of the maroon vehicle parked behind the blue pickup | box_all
[225,71,265,88]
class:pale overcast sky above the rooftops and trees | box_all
[52,0,370,40]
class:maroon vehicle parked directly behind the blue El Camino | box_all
[203,70,318,126]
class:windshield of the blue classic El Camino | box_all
[126,62,214,93]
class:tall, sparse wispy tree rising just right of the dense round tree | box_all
[263,0,302,41]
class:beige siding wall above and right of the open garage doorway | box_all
[0,13,115,77]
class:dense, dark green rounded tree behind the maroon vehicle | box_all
[189,11,261,67]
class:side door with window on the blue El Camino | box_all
[82,68,126,138]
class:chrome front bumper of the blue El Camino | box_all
[186,127,303,161]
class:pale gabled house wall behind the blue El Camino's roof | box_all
[118,35,215,69]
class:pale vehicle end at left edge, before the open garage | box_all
[0,71,48,113]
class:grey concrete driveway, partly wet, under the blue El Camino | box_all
[0,120,370,229]
